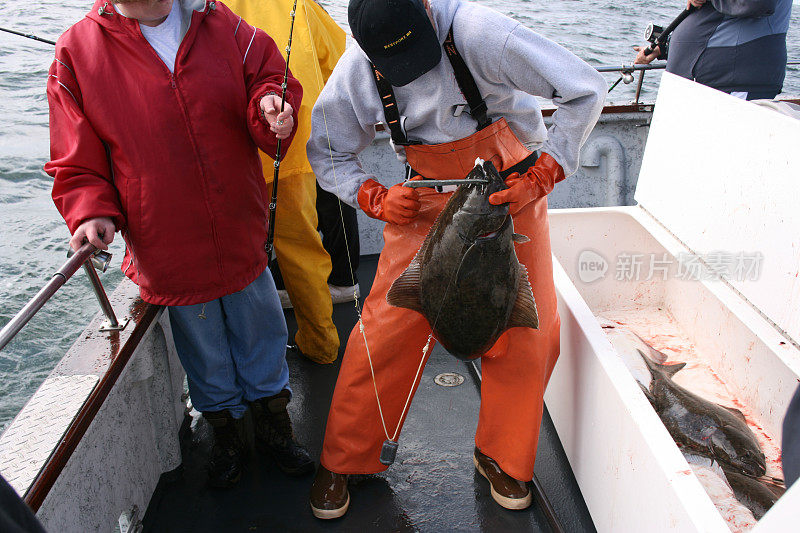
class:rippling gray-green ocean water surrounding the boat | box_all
[0,0,800,431]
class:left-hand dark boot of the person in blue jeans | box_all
[203,409,245,489]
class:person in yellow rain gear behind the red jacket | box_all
[225,0,345,364]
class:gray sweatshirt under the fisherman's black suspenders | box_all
[306,0,607,206]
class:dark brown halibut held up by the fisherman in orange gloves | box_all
[386,160,539,360]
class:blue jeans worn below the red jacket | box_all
[169,269,289,418]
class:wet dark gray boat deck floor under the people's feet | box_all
[144,257,594,533]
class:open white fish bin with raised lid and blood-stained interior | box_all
[545,74,800,532]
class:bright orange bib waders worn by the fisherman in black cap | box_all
[320,119,559,481]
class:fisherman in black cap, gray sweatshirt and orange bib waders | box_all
[308,0,606,518]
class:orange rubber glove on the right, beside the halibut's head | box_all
[489,152,565,215]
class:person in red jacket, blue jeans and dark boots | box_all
[45,0,313,487]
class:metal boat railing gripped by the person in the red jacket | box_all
[0,243,127,350]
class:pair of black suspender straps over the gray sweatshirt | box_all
[370,27,492,146]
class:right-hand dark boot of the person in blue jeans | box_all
[250,389,314,476]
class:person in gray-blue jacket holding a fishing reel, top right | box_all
[634,0,792,100]
